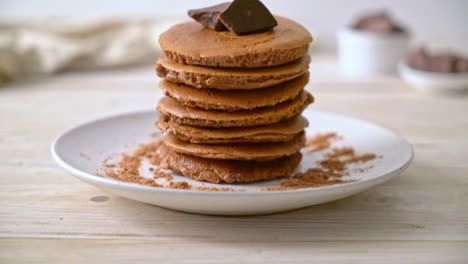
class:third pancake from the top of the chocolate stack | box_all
[159,73,309,112]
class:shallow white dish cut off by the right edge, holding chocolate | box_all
[398,60,468,93]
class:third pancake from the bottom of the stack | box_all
[156,116,308,144]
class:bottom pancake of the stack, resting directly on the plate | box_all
[157,144,302,183]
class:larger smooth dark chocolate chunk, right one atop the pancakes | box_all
[219,0,278,35]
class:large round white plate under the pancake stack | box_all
[52,110,413,215]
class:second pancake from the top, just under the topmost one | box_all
[154,55,310,90]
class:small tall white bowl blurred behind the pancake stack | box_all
[338,28,409,76]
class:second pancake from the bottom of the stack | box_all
[164,132,305,161]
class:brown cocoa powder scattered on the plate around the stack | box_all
[98,132,376,192]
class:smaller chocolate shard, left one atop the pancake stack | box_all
[187,2,231,31]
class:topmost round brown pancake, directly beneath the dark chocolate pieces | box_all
[159,16,312,68]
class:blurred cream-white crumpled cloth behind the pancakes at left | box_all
[0,18,180,83]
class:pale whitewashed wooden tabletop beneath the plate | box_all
[0,55,468,263]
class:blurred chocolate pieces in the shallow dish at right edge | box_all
[408,47,468,73]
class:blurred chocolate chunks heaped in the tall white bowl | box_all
[352,12,406,33]
